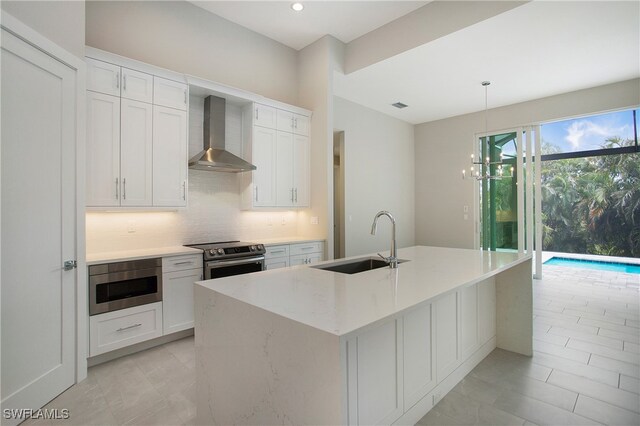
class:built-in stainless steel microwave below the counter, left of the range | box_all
[89,257,162,315]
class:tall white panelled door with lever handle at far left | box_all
[0,30,76,424]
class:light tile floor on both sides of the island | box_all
[25,266,640,426]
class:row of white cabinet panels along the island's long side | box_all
[342,278,496,425]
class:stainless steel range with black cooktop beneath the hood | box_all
[188,241,266,280]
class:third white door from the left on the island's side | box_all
[434,292,459,383]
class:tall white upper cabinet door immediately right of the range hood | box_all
[251,126,277,207]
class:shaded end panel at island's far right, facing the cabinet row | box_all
[496,259,533,356]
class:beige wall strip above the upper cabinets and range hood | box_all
[86,1,298,105]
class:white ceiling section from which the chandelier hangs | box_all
[334,1,640,124]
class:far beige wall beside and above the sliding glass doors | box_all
[415,79,640,248]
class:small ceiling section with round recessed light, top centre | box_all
[191,0,429,50]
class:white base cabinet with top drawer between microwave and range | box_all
[162,254,203,334]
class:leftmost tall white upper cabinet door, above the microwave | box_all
[87,91,120,206]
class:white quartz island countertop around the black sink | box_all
[197,246,531,336]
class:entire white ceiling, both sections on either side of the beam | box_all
[193,0,640,124]
